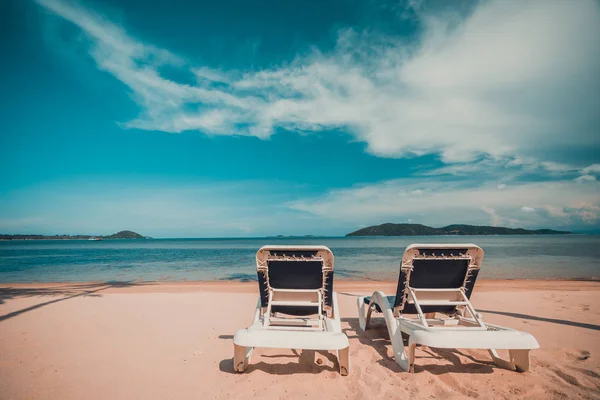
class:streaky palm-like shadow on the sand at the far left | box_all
[0,281,151,322]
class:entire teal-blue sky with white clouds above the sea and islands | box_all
[0,0,600,237]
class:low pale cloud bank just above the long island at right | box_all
[288,178,600,227]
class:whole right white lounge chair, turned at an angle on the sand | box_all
[358,244,539,372]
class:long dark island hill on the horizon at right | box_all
[346,223,571,236]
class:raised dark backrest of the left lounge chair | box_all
[256,246,334,316]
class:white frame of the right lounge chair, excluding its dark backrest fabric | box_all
[357,244,539,372]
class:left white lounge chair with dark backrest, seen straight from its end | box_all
[233,246,349,375]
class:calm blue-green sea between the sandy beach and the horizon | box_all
[0,235,600,282]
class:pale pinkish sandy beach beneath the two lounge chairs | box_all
[0,280,600,400]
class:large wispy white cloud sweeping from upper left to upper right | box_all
[37,0,600,163]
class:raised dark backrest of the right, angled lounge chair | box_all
[394,244,483,314]
